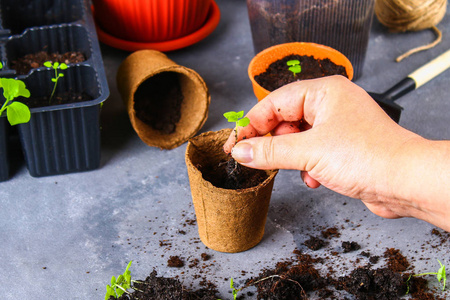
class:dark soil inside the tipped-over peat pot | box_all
[134,72,184,134]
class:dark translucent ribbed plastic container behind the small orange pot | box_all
[247,0,375,80]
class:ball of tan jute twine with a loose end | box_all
[375,0,447,62]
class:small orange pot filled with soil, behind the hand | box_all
[248,43,353,101]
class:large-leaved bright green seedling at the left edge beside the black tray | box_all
[0,63,31,126]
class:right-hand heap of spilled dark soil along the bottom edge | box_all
[245,237,440,300]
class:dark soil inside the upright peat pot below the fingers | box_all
[197,158,269,190]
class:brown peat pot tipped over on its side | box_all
[117,50,211,149]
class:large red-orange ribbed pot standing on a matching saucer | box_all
[93,0,212,42]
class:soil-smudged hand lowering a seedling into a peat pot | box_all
[224,76,423,218]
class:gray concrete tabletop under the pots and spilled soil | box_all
[0,0,450,299]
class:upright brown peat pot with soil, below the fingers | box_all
[186,129,278,253]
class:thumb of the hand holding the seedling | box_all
[231,130,320,171]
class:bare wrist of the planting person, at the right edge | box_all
[388,135,450,230]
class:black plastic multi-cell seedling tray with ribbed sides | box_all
[0,0,109,181]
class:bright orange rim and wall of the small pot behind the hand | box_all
[248,42,353,101]
